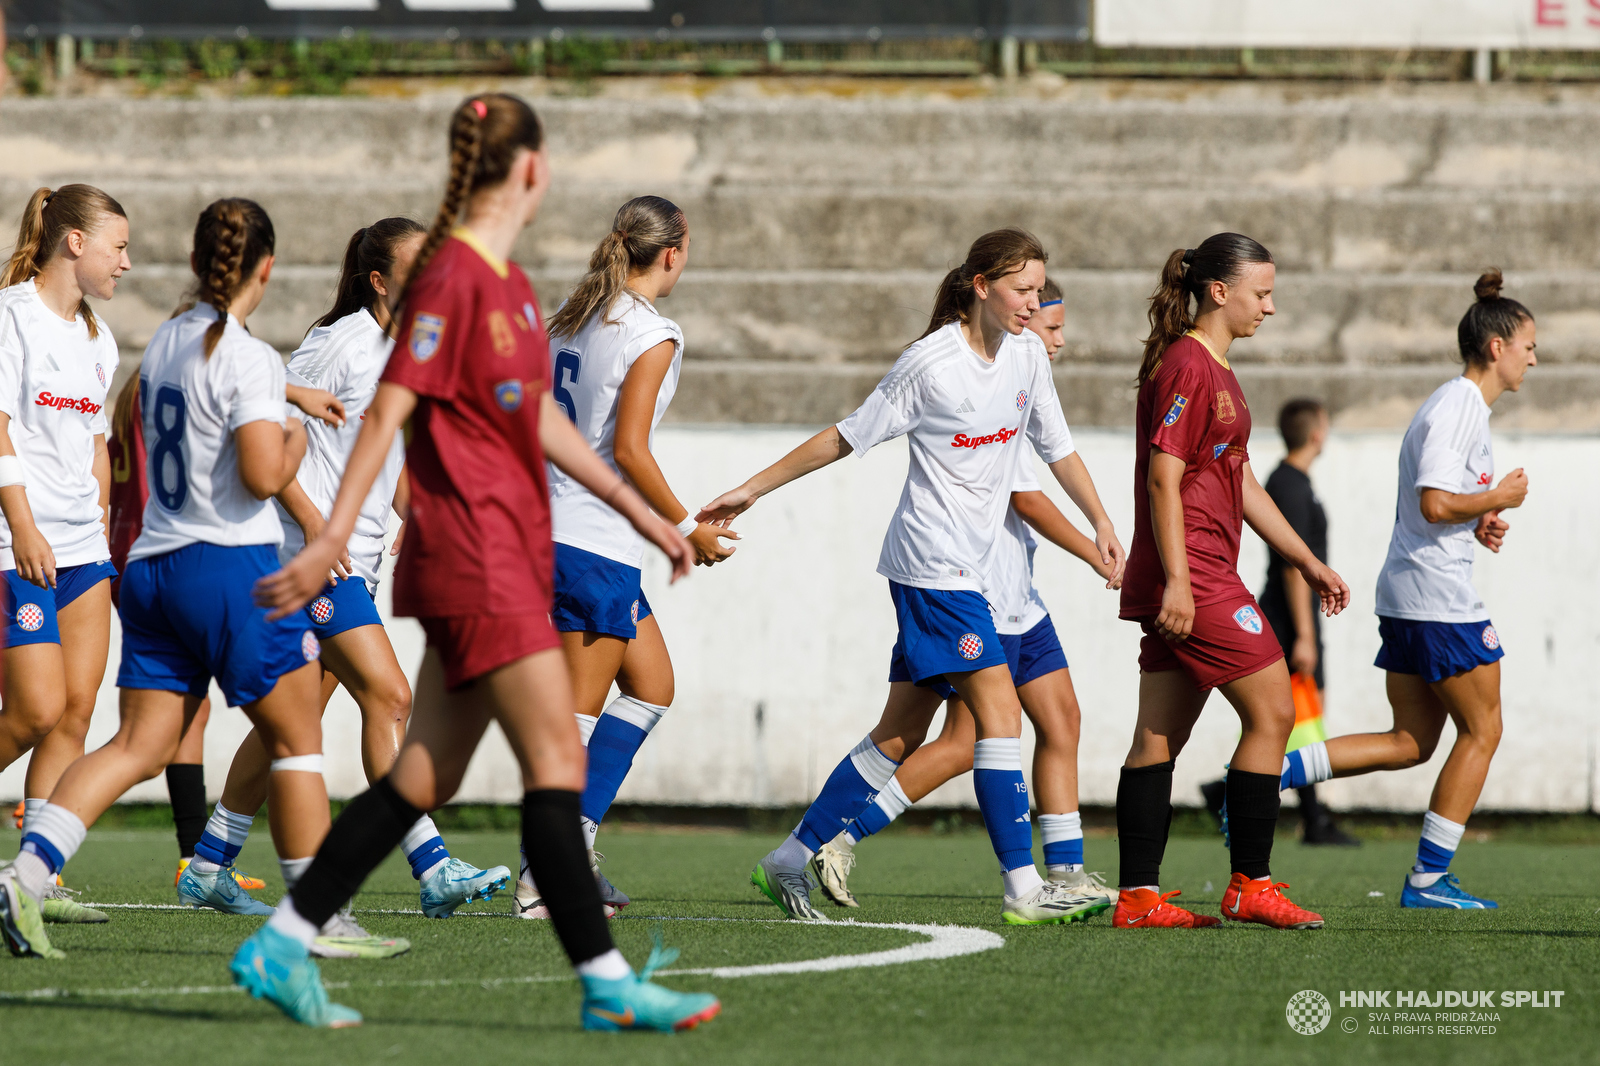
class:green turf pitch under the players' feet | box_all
[0,829,1600,1066]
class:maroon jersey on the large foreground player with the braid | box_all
[382,230,554,618]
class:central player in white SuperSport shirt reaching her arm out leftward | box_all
[699,229,1123,924]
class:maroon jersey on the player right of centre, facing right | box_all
[1122,333,1250,619]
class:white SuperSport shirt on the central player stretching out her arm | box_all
[838,322,1074,599]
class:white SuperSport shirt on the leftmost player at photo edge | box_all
[0,282,117,570]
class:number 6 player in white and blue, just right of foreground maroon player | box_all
[517,197,736,917]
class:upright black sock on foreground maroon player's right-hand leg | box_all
[531,789,613,965]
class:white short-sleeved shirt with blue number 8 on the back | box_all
[128,304,285,562]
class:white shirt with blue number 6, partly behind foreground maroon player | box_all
[550,293,683,567]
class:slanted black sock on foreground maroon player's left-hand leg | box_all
[290,778,422,928]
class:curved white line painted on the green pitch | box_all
[0,903,1005,1002]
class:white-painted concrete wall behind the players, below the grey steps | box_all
[0,426,1600,810]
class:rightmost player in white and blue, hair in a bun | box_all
[1283,269,1539,911]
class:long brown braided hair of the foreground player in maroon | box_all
[389,93,544,330]
